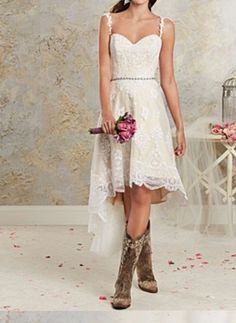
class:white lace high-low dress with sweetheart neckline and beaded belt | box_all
[88,12,188,256]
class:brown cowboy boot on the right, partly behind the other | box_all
[136,219,158,293]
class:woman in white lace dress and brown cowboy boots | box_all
[89,0,188,309]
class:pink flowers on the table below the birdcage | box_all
[210,122,236,142]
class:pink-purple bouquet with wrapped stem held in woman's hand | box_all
[88,112,136,144]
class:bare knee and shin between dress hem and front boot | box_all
[127,184,151,239]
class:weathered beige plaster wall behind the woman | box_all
[0,0,236,205]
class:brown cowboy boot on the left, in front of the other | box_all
[111,226,145,309]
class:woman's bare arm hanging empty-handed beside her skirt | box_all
[160,18,186,156]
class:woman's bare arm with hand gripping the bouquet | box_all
[99,16,115,133]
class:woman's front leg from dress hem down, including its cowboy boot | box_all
[112,185,150,309]
